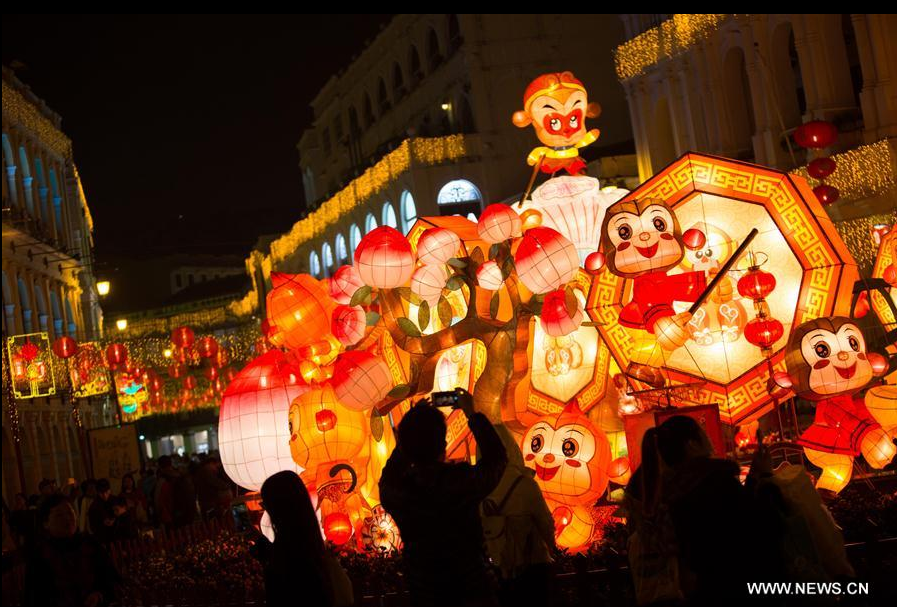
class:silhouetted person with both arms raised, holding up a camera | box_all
[380,391,507,605]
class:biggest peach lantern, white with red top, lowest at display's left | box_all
[218,350,308,491]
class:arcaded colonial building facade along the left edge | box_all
[2,68,111,503]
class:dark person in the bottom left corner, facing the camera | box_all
[25,495,118,607]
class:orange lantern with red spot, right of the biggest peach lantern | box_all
[289,384,368,487]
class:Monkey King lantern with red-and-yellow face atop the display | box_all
[512,72,601,175]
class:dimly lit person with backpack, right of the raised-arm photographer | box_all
[480,424,555,607]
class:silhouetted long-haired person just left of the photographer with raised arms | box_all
[257,470,333,607]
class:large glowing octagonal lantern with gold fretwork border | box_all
[586,154,858,424]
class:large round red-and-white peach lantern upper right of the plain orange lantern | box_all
[354,226,414,290]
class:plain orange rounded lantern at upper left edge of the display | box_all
[267,272,333,350]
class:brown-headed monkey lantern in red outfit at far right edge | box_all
[775,316,897,493]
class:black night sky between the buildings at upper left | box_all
[3,15,389,264]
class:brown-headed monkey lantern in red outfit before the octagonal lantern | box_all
[585,198,707,386]
